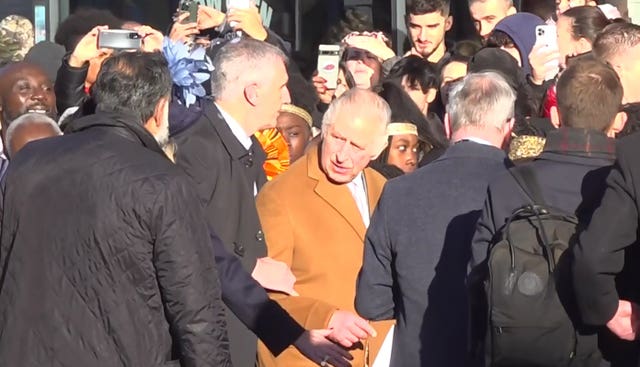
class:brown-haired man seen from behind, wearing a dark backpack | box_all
[471,59,626,366]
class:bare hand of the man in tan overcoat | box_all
[327,310,377,348]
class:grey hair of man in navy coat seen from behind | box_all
[447,71,516,132]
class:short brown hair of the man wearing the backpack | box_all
[556,57,623,132]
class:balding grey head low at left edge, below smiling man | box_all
[5,113,62,158]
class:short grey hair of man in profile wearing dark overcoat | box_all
[211,38,288,100]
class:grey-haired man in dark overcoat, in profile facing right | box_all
[174,39,344,367]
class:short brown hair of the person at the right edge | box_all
[593,23,640,61]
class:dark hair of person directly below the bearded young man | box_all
[387,55,440,93]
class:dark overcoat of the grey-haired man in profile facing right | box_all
[174,101,300,367]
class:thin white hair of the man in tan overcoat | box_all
[322,88,391,138]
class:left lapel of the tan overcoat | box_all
[306,143,366,241]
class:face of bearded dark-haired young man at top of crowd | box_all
[407,11,452,62]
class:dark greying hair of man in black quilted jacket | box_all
[91,51,173,124]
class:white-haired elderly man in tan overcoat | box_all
[257,89,391,367]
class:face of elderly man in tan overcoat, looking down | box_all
[320,112,387,184]
